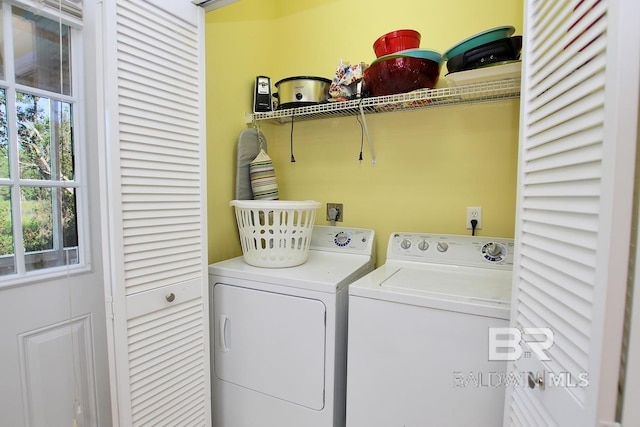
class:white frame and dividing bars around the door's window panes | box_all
[0,0,91,289]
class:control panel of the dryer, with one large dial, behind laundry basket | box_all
[310,225,375,254]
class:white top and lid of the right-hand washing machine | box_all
[349,265,511,319]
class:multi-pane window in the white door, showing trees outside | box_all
[0,0,84,282]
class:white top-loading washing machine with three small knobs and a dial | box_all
[347,233,513,427]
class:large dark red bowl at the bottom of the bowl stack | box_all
[363,56,441,96]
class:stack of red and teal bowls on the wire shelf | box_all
[363,30,442,96]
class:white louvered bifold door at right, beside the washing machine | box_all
[504,0,640,427]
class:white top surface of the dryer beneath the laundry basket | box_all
[209,250,374,293]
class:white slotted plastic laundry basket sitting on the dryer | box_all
[230,200,321,267]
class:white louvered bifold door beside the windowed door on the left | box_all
[105,0,210,427]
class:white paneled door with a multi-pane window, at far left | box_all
[0,0,111,427]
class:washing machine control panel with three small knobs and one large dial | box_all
[387,232,514,269]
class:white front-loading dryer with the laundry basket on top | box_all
[209,226,375,427]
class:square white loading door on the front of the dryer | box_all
[212,283,326,411]
